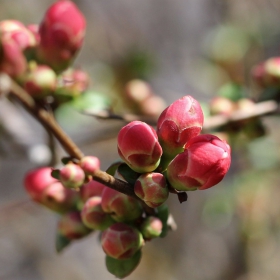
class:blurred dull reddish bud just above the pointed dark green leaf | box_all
[57,211,91,240]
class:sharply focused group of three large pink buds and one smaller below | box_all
[118,96,231,192]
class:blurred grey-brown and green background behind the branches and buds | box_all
[0,0,280,280]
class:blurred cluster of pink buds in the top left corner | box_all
[0,0,89,104]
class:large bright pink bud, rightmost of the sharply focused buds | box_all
[167,134,231,191]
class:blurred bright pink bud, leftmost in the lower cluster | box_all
[24,167,58,202]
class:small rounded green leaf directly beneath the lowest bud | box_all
[105,250,142,279]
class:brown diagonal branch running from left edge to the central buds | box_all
[0,73,138,198]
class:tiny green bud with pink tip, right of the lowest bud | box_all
[140,216,163,239]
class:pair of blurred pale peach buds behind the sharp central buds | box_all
[125,79,166,116]
